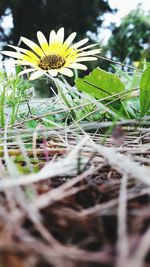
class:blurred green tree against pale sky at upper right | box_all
[105,8,150,62]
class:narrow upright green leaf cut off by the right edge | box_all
[140,67,150,116]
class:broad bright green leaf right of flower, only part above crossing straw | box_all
[76,68,125,99]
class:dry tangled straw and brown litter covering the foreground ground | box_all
[0,126,150,267]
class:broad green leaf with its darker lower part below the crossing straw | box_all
[76,68,129,117]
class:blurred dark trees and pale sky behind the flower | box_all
[0,0,150,94]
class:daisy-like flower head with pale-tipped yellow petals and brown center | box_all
[2,28,101,80]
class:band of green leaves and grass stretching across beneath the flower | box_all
[0,54,150,127]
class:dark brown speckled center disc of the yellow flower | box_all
[38,54,65,70]
